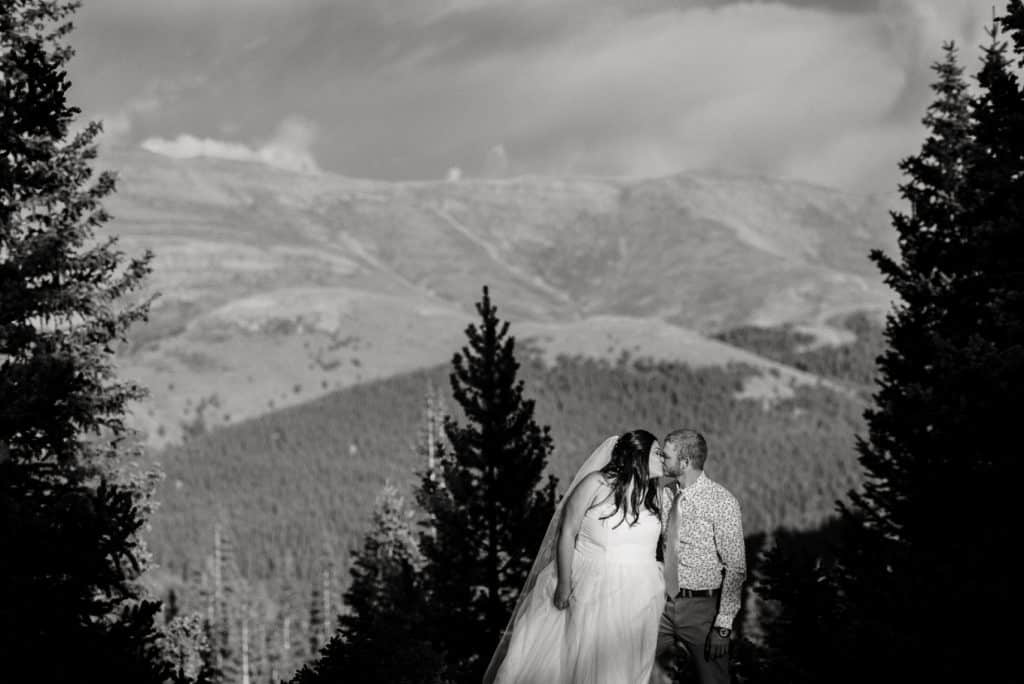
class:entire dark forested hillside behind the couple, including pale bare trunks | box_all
[140,316,879,673]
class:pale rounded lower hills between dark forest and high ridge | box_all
[124,288,820,444]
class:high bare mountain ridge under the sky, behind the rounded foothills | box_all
[101,148,894,332]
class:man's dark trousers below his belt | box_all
[651,596,730,684]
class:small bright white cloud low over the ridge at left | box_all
[141,117,319,173]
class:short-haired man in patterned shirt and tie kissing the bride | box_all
[651,430,746,684]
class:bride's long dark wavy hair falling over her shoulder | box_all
[601,430,658,527]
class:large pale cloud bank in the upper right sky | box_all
[407,0,987,191]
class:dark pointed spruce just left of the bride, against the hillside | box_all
[419,288,556,682]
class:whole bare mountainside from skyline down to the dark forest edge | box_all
[102,152,894,443]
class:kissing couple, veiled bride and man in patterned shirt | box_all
[483,430,746,684]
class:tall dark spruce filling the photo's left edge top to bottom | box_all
[0,0,167,683]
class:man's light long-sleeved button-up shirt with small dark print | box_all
[662,473,746,629]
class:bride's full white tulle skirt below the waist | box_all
[495,551,665,684]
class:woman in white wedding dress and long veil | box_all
[483,430,665,684]
